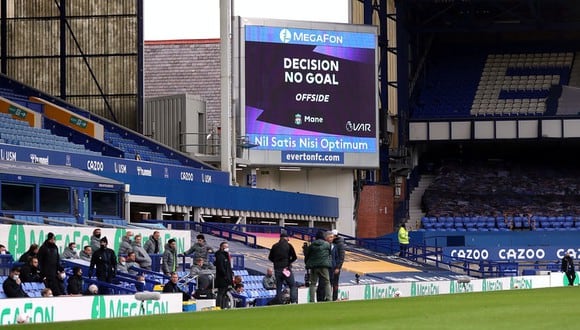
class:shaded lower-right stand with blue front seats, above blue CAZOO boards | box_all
[422,164,580,231]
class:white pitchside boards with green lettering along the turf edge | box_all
[0,272,578,325]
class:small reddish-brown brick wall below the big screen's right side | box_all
[356,185,394,238]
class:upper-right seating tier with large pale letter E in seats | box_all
[413,46,574,119]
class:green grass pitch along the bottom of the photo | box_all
[7,287,580,330]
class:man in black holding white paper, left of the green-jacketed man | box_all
[268,232,298,303]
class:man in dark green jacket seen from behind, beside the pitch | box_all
[304,231,332,302]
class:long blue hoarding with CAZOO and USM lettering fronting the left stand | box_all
[0,144,338,217]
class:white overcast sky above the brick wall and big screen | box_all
[144,0,349,40]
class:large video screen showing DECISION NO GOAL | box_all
[242,21,378,168]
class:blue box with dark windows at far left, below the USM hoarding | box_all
[0,161,125,224]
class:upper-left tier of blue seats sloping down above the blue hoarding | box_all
[0,77,207,168]
